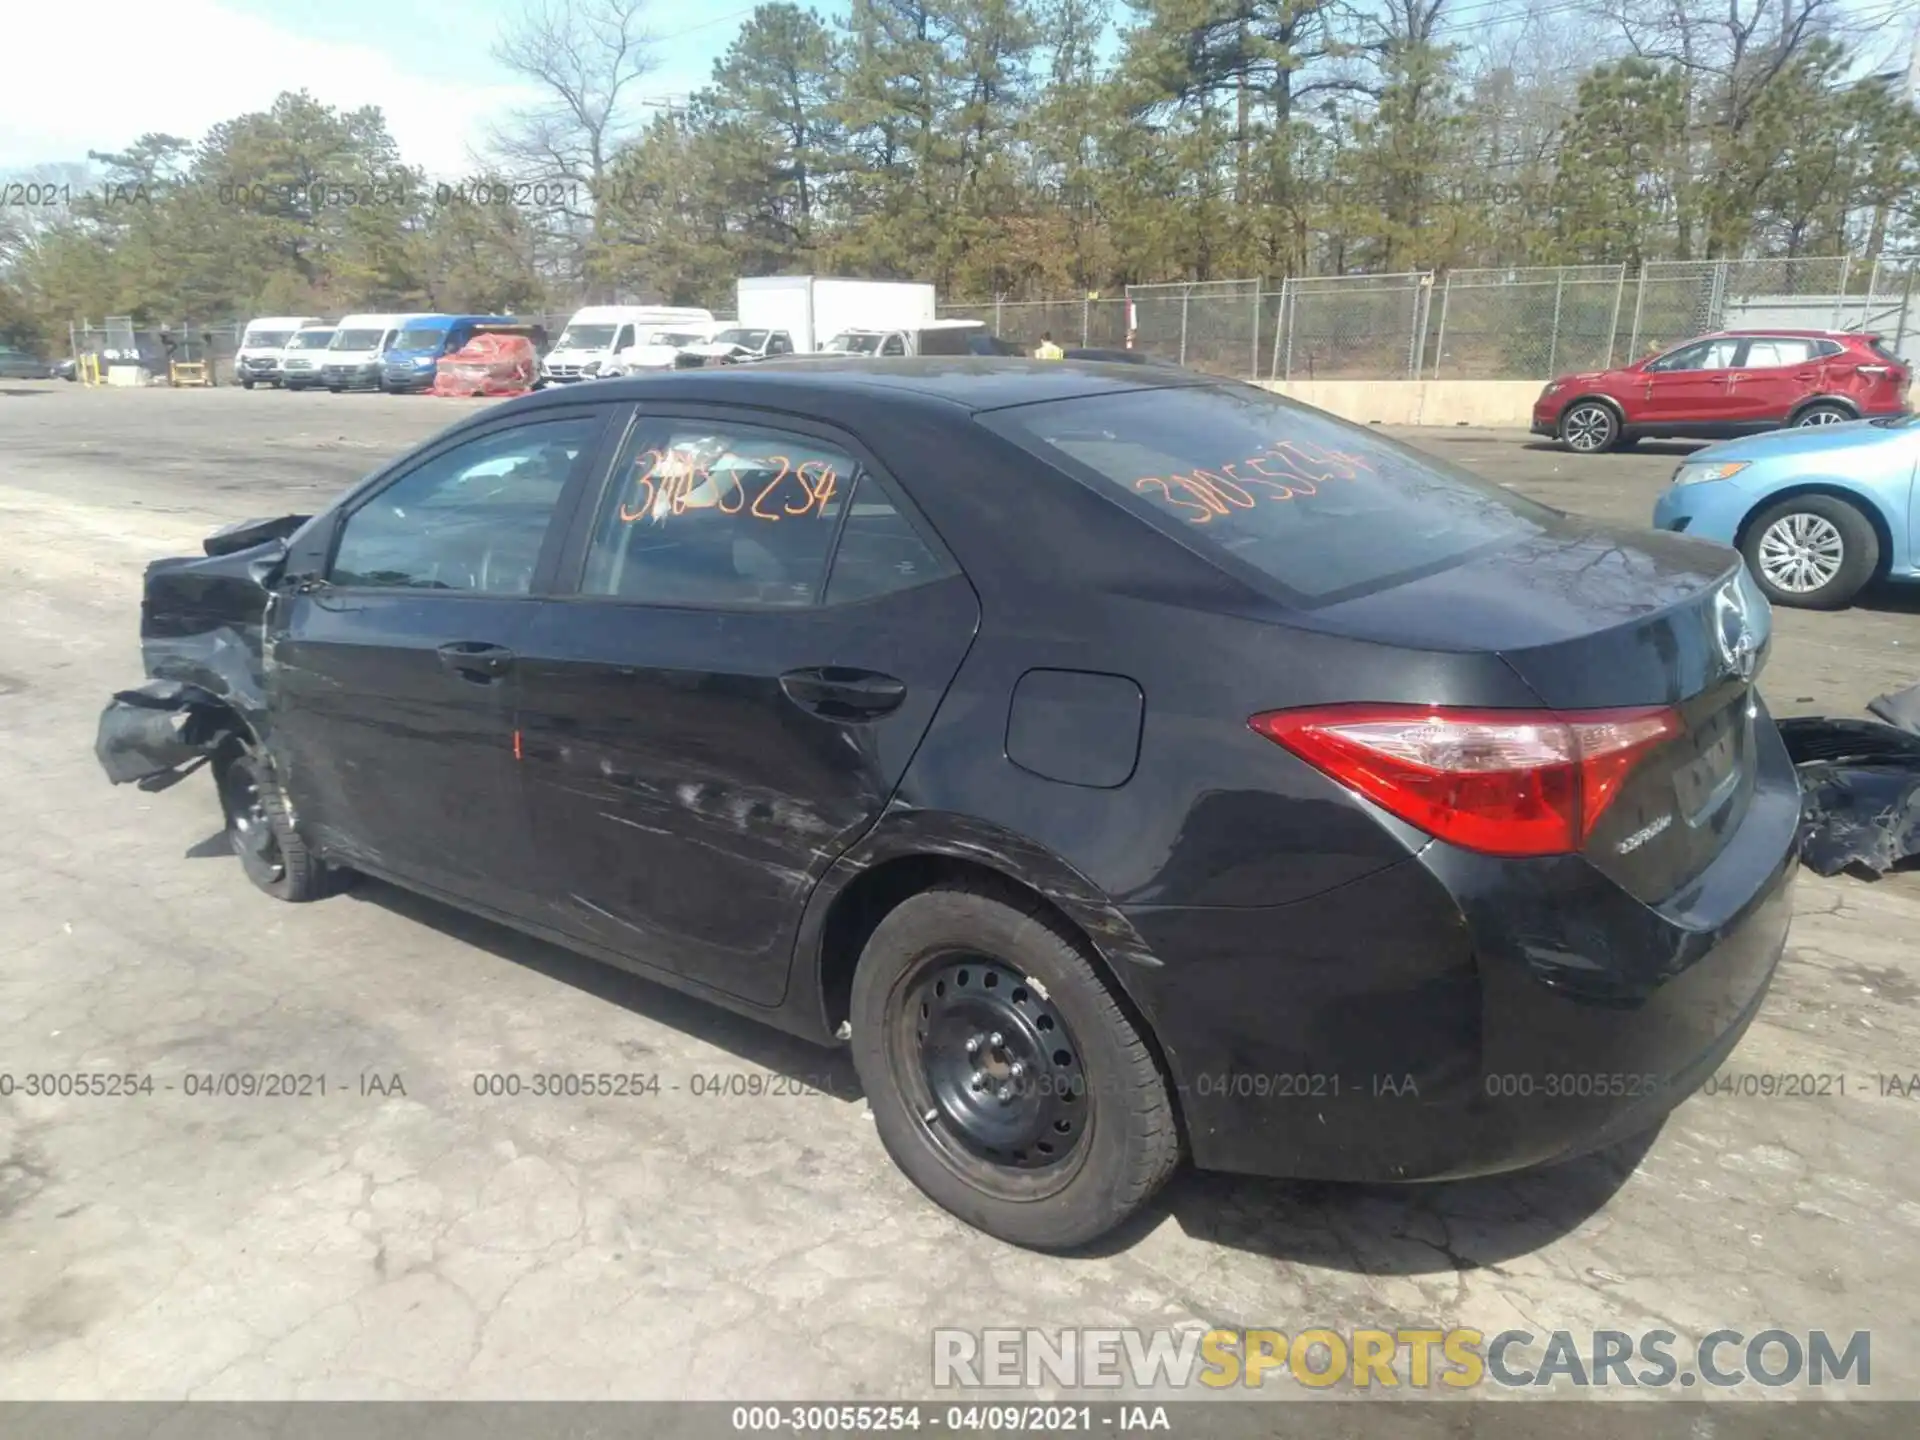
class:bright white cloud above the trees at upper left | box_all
[0,0,541,177]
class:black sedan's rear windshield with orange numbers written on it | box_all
[981,386,1551,605]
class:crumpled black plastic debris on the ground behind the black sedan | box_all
[1780,685,1920,876]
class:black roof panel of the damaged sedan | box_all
[509,355,1223,419]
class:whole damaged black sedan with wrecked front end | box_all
[98,359,1797,1248]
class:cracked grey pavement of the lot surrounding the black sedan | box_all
[0,384,1920,1400]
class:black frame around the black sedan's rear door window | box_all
[543,401,973,614]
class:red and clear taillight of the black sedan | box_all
[1248,705,1684,856]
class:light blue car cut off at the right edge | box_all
[1653,415,1920,611]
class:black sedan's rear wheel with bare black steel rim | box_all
[849,883,1181,1250]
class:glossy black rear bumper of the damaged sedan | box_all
[1123,726,1799,1181]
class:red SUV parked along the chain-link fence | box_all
[1532,330,1907,455]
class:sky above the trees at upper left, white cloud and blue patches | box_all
[0,0,845,177]
